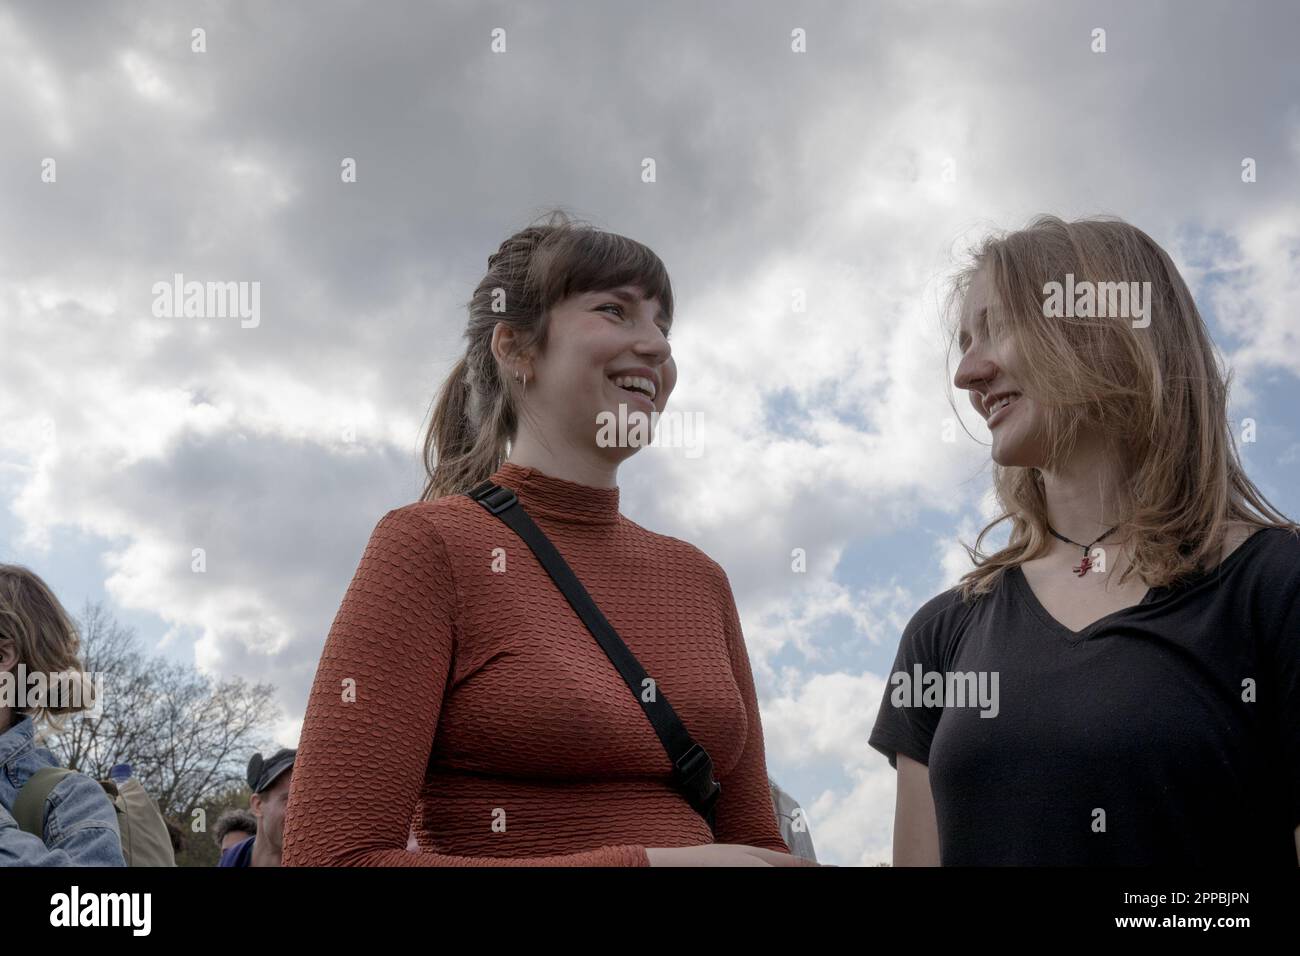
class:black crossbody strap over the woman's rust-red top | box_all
[467,481,722,830]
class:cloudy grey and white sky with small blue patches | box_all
[0,0,1300,864]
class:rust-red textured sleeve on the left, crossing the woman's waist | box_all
[282,505,649,866]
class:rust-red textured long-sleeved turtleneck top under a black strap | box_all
[283,462,789,866]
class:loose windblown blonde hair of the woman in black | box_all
[949,216,1300,598]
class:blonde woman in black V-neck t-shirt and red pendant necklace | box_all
[870,216,1300,866]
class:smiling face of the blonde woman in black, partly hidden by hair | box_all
[953,269,1048,468]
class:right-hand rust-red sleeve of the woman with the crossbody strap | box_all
[714,563,790,853]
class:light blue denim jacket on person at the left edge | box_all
[0,714,126,866]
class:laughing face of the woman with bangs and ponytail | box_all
[497,286,677,460]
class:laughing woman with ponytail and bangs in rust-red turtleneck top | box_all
[283,215,800,866]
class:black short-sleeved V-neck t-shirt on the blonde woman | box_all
[870,528,1300,866]
